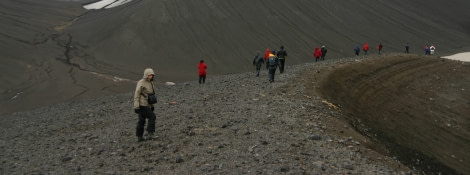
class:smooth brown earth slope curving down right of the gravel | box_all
[312,55,470,174]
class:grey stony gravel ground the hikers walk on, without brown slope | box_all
[0,56,413,174]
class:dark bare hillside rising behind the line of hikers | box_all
[0,0,470,113]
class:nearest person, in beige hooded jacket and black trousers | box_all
[134,68,157,142]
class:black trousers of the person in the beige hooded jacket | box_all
[135,106,157,137]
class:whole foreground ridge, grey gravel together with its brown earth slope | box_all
[0,55,470,174]
